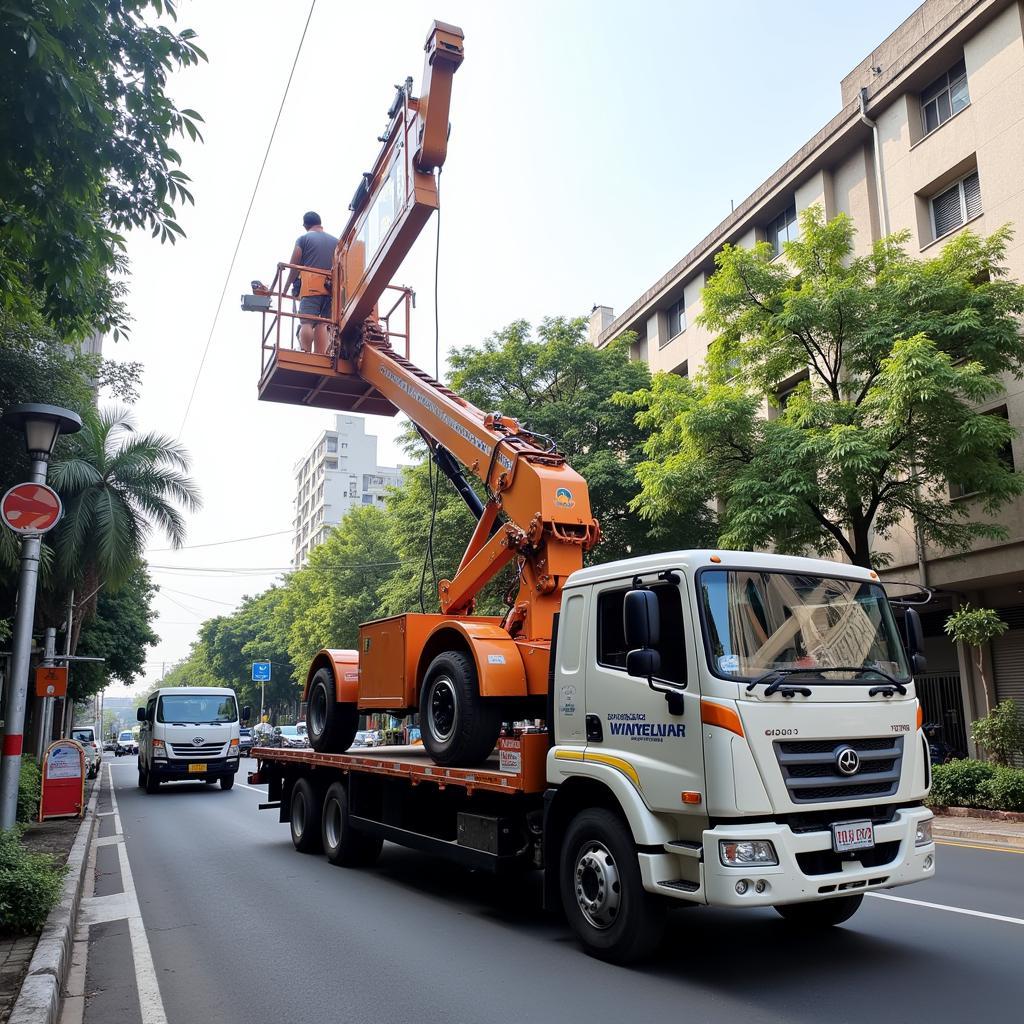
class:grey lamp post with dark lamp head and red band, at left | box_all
[0,403,82,829]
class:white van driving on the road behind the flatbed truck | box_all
[137,686,249,793]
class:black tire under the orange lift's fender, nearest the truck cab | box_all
[420,650,502,768]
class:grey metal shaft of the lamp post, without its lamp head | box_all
[0,459,46,830]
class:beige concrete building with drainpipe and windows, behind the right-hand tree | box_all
[591,0,1024,751]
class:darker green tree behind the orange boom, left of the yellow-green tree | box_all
[450,316,711,562]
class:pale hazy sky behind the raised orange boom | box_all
[105,0,916,695]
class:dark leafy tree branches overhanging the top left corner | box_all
[0,0,206,337]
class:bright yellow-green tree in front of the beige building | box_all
[621,207,1024,566]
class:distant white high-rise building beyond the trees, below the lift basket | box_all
[292,415,401,568]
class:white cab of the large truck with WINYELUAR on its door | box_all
[547,551,935,929]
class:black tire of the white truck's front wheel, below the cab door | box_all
[558,808,667,964]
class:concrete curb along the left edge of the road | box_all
[7,784,99,1024]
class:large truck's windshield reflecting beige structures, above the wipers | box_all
[699,569,909,680]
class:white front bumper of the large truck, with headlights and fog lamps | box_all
[701,807,935,906]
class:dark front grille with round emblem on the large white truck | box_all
[774,736,903,804]
